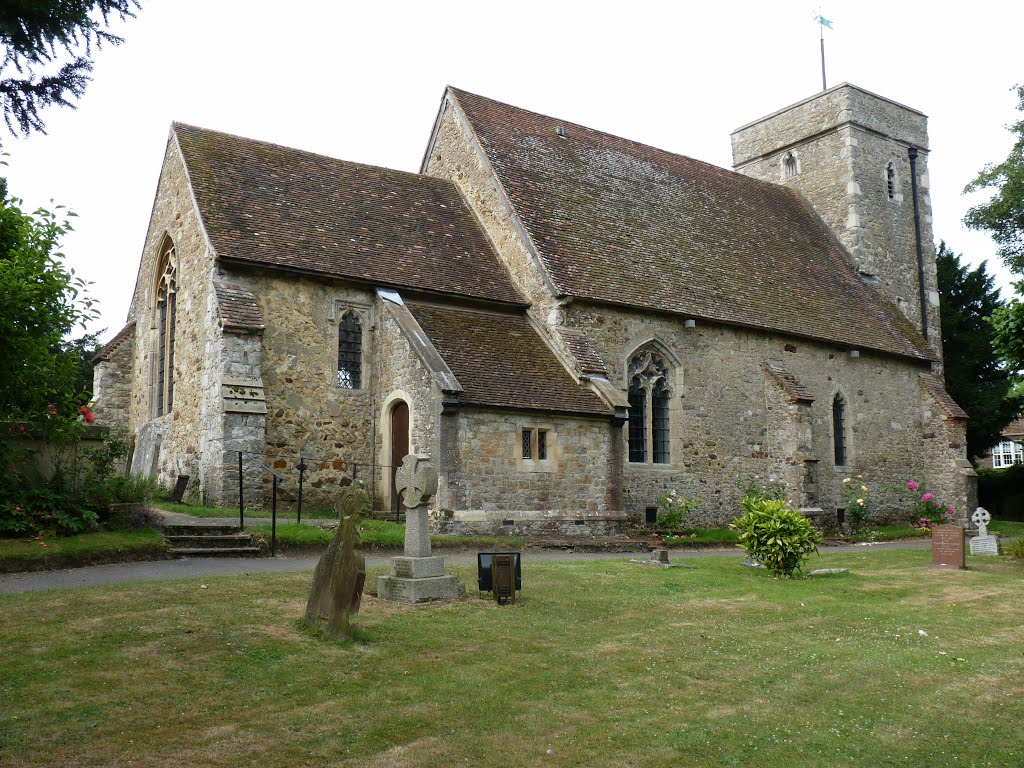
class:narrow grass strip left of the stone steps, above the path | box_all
[0,528,167,572]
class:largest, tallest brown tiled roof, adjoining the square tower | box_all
[449,88,932,359]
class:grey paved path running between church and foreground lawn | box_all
[0,541,931,594]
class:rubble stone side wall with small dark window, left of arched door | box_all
[228,268,375,507]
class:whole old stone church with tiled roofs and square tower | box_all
[95,85,974,535]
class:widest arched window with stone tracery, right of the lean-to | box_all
[627,350,672,464]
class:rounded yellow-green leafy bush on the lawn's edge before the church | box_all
[729,497,821,575]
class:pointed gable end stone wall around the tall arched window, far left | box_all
[128,135,217,493]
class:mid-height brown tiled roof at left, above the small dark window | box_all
[173,123,523,304]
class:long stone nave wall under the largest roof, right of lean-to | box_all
[567,302,958,524]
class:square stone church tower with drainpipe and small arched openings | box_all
[732,83,942,359]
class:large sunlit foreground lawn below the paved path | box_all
[0,550,1024,768]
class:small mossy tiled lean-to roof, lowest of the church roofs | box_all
[409,303,611,416]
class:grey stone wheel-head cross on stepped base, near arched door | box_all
[377,454,466,603]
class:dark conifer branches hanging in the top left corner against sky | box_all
[0,0,140,135]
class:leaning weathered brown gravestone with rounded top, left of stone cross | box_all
[306,482,371,638]
